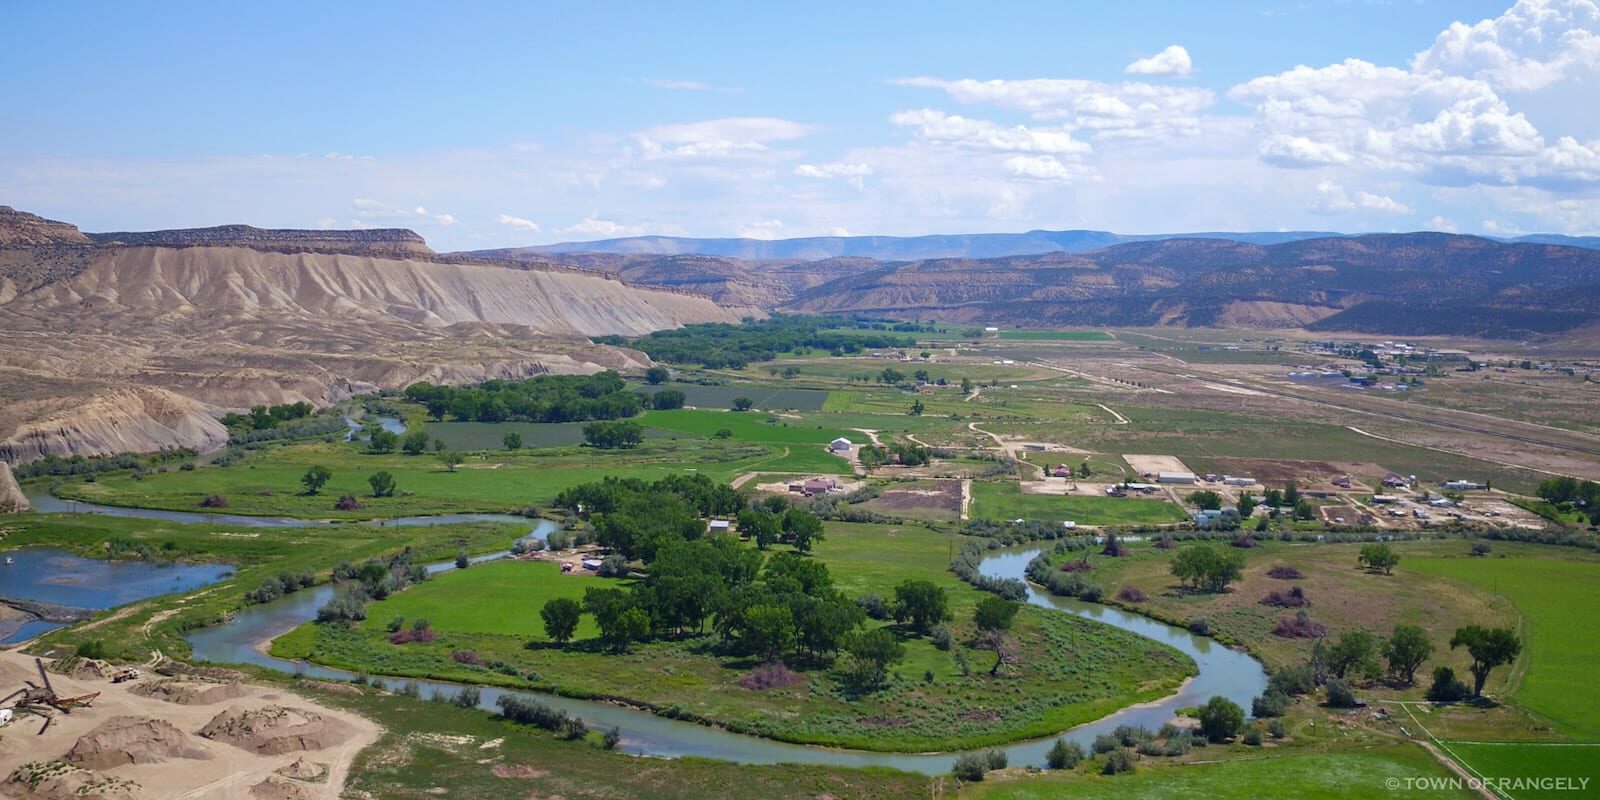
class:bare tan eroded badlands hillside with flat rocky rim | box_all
[0,206,750,464]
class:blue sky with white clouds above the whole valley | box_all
[0,0,1600,250]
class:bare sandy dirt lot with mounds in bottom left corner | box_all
[0,651,379,800]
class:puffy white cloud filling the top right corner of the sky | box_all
[1411,0,1600,91]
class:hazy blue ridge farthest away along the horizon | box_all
[474,230,1600,261]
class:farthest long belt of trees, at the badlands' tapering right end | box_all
[595,314,915,370]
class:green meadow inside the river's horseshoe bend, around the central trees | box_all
[272,523,1194,752]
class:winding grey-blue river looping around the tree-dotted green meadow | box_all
[12,494,1267,774]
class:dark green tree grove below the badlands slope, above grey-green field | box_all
[405,370,646,422]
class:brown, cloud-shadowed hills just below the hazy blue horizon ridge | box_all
[474,232,1600,338]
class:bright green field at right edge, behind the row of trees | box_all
[1400,556,1600,741]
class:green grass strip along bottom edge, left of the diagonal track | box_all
[962,746,1477,800]
